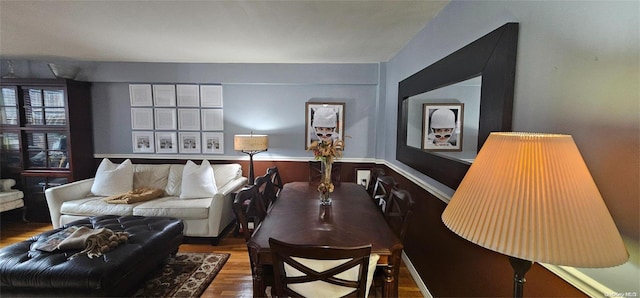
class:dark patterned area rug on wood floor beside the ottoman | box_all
[133,252,230,297]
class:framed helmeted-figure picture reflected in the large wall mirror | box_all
[422,103,464,151]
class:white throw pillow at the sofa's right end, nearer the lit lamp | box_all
[180,159,218,199]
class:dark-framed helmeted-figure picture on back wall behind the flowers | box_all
[305,102,344,149]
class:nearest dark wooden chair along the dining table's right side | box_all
[384,189,414,243]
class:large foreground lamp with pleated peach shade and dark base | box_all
[442,133,629,297]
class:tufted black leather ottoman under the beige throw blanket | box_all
[0,215,183,297]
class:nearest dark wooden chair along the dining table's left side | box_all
[233,185,267,241]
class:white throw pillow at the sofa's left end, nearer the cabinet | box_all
[91,158,133,197]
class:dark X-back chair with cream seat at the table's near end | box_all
[269,238,379,297]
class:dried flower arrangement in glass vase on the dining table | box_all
[309,140,343,205]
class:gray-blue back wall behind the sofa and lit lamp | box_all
[3,61,379,159]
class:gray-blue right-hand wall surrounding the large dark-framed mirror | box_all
[384,0,640,295]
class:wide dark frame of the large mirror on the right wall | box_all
[396,23,518,189]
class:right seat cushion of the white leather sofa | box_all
[133,197,213,219]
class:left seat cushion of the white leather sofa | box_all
[60,197,140,216]
